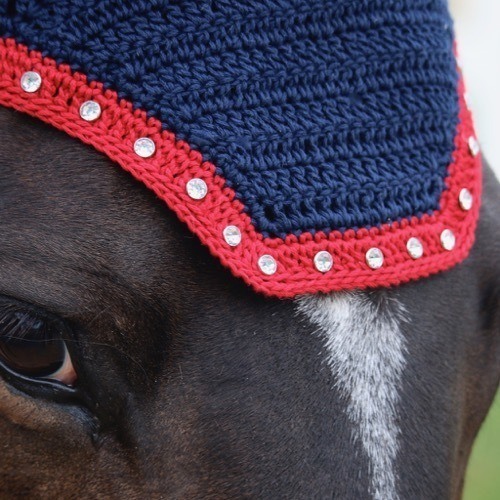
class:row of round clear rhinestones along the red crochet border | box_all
[21,71,480,276]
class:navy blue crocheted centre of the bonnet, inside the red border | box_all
[0,0,458,237]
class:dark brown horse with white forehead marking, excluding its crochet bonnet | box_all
[0,2,500,500]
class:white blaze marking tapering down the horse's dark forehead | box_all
[297,292,405,500]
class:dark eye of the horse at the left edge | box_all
[0,306,77,386]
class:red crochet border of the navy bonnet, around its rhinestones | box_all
[0,39,481,298]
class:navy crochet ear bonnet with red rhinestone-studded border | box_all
[0,0,481,297]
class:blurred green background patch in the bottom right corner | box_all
[463,394,500,500]
